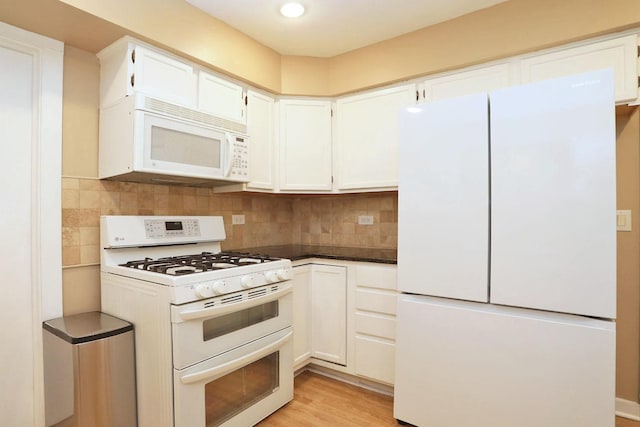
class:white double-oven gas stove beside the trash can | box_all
[100,216,293,427]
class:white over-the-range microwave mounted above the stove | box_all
[99,95,249,185]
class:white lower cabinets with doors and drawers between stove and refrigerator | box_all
[293,259,397,385]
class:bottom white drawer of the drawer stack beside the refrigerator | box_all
[356,336,396,384]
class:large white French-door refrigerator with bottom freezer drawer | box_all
[394,70,616,427]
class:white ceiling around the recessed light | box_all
[186,0,505,57]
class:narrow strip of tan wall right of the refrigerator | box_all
[616,108,640,401]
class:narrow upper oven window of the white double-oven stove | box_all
[202,301,278,341]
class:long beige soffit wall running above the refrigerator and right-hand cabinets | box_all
[329,0,640,94]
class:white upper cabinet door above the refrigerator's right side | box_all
[521,34,638,102]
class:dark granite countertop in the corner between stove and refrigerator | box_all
[234,245,398,264]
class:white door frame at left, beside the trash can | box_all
[0,22,64,426]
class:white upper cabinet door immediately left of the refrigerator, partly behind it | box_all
[335,84,416,190]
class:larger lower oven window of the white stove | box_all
[204,351,280,427]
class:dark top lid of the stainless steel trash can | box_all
[42,311,133,344]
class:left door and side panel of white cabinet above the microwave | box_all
[98,37,197,108]
